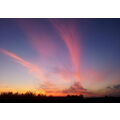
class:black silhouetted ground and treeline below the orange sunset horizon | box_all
[0,92,120,103]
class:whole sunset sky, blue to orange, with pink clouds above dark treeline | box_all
[0,18,120,96]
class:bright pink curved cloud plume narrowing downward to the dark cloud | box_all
[50,19,81,82]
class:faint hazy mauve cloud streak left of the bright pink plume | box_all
[18,19,56,57]
